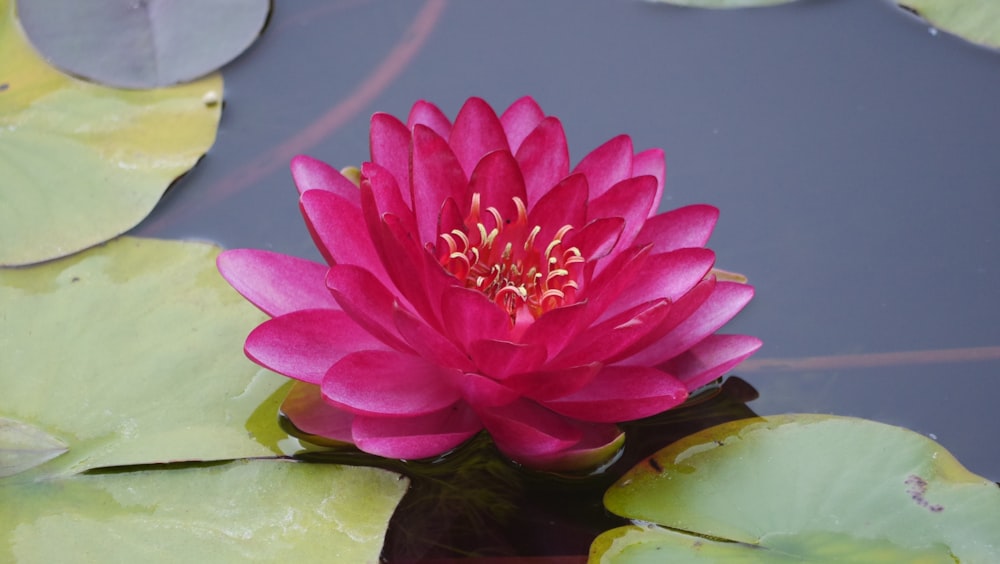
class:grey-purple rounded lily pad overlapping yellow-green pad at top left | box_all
[18,0,271,88]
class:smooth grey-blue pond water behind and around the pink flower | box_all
[134,0,1000,554]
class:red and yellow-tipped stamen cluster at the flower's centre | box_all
[438,194,586,323]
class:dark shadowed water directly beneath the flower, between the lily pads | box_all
[284,377,757,562]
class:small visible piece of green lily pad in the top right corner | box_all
[897,0,1000,48]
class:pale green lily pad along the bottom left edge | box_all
[0,460,408,563]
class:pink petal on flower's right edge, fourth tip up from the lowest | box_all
[599,248,715,319]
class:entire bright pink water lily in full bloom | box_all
[218,97,760,468]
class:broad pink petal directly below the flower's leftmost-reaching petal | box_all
[244,309,386,384]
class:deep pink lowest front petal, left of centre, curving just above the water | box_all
[352,403,483,460]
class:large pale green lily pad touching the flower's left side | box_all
[0,238,286,474]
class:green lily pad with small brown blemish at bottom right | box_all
[591,415,1000,562]
